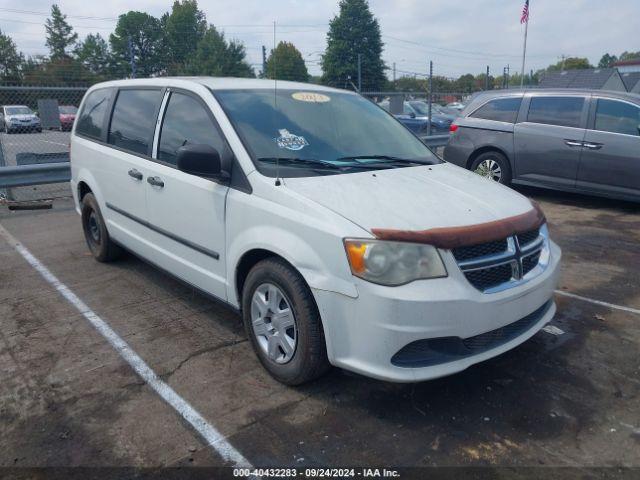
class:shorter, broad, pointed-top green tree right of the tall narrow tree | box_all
[185,25,255,77]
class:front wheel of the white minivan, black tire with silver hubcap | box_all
[242,258,330,385]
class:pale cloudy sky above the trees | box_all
[0,0,640,77]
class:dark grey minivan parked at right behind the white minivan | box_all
[444,89,640,200]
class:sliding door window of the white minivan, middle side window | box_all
[108,89,162,155]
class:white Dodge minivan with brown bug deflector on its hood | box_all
[71,77,560,385]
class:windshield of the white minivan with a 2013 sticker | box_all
[215,89,440,177]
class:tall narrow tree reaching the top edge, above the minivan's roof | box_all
[161,0,207,75]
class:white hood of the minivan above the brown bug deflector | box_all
[284,163,532,231]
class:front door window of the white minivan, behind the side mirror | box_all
[158,92,226,165]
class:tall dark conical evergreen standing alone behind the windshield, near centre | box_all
[322,0,386,90]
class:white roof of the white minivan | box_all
[86,77,354,93]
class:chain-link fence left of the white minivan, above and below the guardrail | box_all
[0,85,88,202]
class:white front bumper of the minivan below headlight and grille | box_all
[313,242,561,382]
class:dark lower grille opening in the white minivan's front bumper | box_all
[391,300,553,368]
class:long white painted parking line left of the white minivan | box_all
[0,225,253,468]
